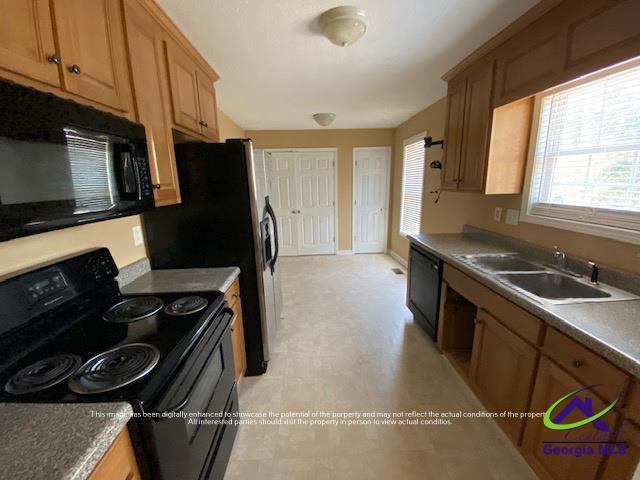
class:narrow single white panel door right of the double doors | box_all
[353,147,390,253]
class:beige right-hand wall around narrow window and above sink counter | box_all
[389,99,640,273]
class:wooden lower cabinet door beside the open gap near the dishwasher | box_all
[470,310,538,444]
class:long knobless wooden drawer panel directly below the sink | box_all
[444,265,543,345]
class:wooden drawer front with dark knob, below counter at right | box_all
[542,328,629,401]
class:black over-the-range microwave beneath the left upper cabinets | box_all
[0,80,154,241]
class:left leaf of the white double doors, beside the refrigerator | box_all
[265,152,299,256]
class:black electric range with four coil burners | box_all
[0,249,238,479]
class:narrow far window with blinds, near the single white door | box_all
[400,132,426,236]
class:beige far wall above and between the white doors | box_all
[246,128,394,250]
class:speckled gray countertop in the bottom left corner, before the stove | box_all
[0,402,133,480]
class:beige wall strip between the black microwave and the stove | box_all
[0,215,146,275]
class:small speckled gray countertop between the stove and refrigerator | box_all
[121,267,240,295]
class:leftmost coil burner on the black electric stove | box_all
[4,355,82,395]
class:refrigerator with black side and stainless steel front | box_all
[143,139,282,375]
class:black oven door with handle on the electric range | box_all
[145,309,237,480]
